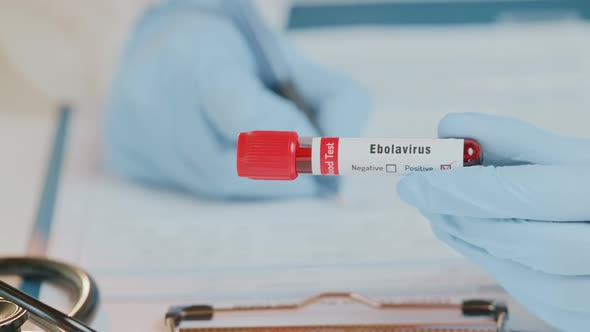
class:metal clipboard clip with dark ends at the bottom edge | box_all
[165,293,508,332]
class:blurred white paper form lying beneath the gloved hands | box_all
[41,18,590,331]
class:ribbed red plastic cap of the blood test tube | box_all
[237,131,299,180]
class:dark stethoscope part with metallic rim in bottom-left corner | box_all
[0,257,99,332]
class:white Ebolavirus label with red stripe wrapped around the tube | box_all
[311,137,464,175]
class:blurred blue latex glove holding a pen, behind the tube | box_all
[105,1,370,198]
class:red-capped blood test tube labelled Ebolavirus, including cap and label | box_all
[237,131,483,180]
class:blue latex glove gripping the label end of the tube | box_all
[398,114,590,332]
